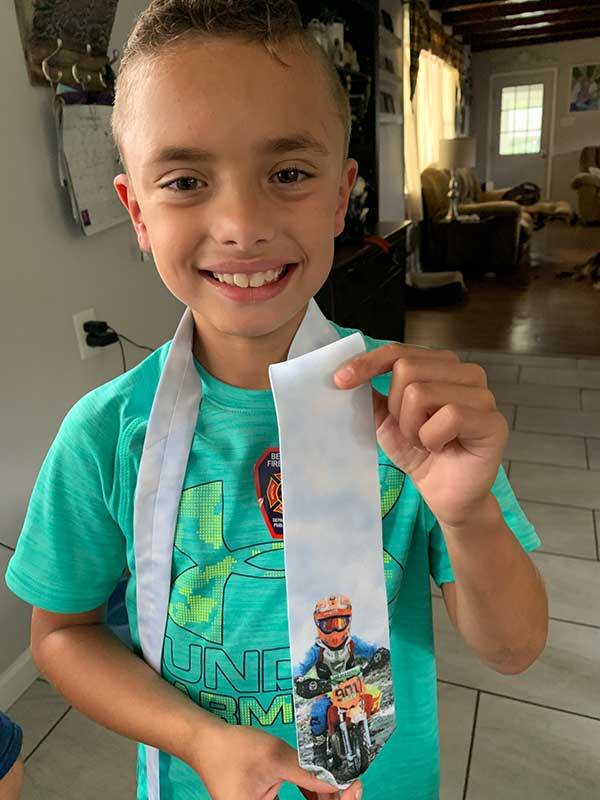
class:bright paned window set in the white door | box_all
[500,83,544,156]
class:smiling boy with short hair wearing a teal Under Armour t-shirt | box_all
[6,0,547,800]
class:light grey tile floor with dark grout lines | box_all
[9,351,600,800]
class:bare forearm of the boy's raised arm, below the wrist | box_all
[442,495,548,673]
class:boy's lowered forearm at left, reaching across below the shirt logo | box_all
[31,625,225,766]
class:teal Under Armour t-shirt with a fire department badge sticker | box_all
[5,326,540,800]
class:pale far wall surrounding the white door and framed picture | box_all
[471,37,600,209]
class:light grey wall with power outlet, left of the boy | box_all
[0,0,183,708]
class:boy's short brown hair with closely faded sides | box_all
[112,0,352,170]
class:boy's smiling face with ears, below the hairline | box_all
[115,38,358,338]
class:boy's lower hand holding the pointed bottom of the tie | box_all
[188,722,362,800]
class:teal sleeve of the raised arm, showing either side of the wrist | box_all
[427,466,542,586]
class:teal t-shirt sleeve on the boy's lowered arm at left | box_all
[5,390,126,614]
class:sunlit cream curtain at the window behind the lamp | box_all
[403,6,460,222]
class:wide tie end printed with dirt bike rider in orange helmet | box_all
[269,333,395,789]
